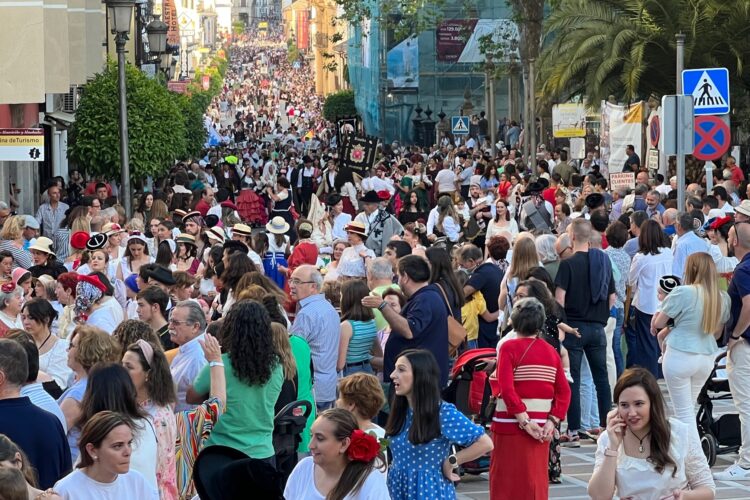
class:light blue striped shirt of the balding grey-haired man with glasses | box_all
[291,294,341,403]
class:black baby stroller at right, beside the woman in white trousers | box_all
[696,352,742,467]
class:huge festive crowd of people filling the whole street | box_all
[0,25,750,500]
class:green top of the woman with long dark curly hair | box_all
[193,353,284,459]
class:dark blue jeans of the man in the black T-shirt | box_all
[563,321,612,431]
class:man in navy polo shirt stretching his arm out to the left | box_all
[362,255,452,387]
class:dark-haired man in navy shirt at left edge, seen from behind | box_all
[0,339,71,490]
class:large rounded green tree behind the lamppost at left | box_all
[68,63,186,179]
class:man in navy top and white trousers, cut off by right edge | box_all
[714,222,750,481]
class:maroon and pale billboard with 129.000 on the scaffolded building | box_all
[435,19,518,64]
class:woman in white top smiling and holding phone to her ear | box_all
[588,368,716,500]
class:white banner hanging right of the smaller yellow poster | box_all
[599,101,645,176]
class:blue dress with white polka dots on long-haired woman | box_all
[388,402,484,500]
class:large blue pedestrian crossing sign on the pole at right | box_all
[682,68,729,116]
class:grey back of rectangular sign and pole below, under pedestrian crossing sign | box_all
[661,95,694,210]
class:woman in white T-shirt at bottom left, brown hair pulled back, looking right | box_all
[54,411,159,500]
